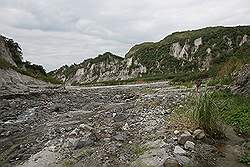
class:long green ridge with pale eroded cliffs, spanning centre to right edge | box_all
[51,26,250,84]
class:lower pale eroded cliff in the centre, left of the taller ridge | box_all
[53,53,147,85]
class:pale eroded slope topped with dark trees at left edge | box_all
[0,36,55,96]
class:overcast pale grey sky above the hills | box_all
[0,0,250,71]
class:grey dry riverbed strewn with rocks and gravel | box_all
[0,82,246,167]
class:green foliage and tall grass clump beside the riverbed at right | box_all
[173,90,250,138]
